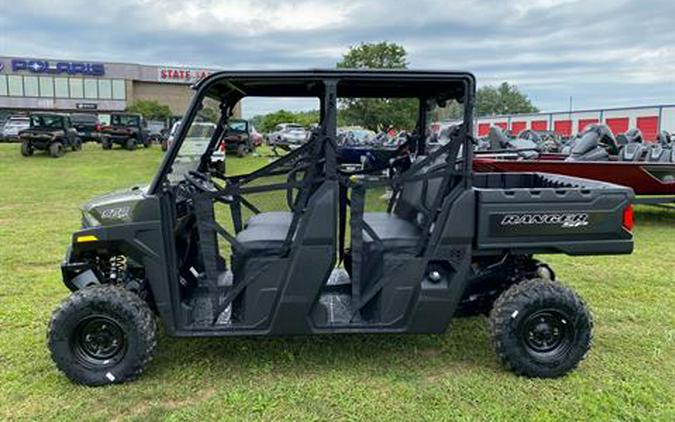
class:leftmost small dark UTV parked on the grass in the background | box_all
[19,113,82,158]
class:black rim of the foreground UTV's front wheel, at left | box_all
[73,315,127,366]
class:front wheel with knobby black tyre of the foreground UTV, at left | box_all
[47,286,156,386]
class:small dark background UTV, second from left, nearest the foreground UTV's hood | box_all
[101,113,152,151]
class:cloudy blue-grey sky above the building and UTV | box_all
[0,0,675,115]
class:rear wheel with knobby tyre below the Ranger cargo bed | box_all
[490,279,593,378]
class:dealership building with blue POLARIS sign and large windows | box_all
[0,56,239,115]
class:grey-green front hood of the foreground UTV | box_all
[82,185,148,227]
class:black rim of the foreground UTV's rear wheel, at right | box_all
[519,309,574,357]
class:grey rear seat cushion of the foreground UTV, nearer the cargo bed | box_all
[363,212,422,249]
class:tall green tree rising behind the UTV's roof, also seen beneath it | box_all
[336,41,418,131]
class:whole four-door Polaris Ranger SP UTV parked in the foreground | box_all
[48,70,633,385]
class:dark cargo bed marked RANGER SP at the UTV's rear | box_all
[474,173,633,255]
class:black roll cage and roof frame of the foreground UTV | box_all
[149,70,476,194]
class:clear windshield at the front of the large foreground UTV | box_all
[168,109,216,183]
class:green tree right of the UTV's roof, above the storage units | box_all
[476,82,539,116]
